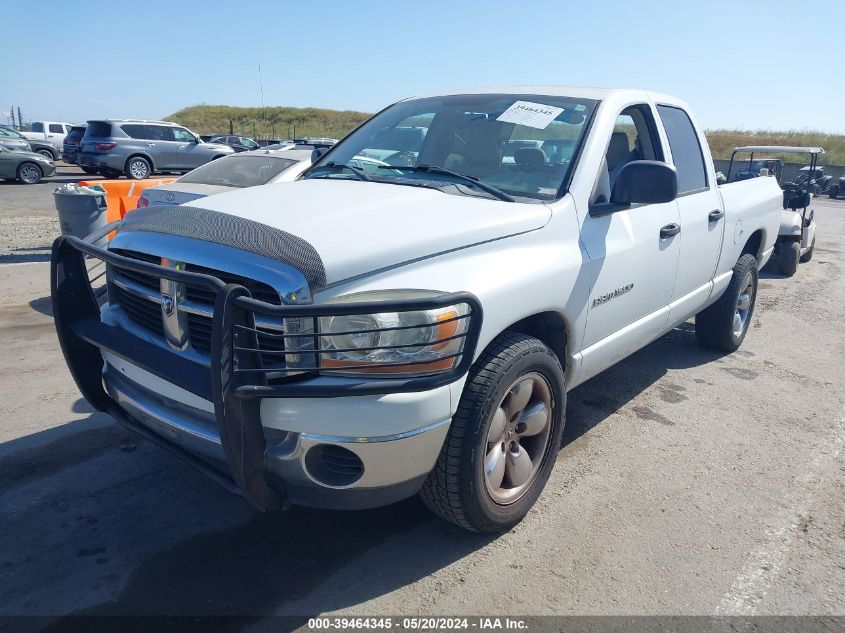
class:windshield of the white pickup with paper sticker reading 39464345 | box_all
[307,94,597,201]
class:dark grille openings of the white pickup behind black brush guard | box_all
[109,249,285,370]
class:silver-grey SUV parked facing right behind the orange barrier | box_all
[77,119,234,180]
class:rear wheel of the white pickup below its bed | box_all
[695,253,757,352]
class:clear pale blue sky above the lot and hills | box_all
[0,0,845,133]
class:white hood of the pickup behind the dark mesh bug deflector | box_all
[188,179,551,284]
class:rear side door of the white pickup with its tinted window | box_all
[657,105,725,316]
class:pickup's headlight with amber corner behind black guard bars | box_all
[318,290,471,375]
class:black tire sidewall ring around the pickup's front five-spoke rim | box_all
[463,339,566,531]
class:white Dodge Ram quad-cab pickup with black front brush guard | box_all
[52,86,781,532]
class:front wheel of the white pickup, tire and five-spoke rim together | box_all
[420,332,566,532]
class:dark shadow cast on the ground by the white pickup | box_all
[0,325,718,630]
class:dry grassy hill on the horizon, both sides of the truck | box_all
[165,105,845,165]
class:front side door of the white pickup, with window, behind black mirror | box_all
[579,104,680,382]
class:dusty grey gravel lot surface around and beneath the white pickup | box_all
[0,175,845,629]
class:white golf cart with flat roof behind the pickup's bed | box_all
[727,145,824,277]
